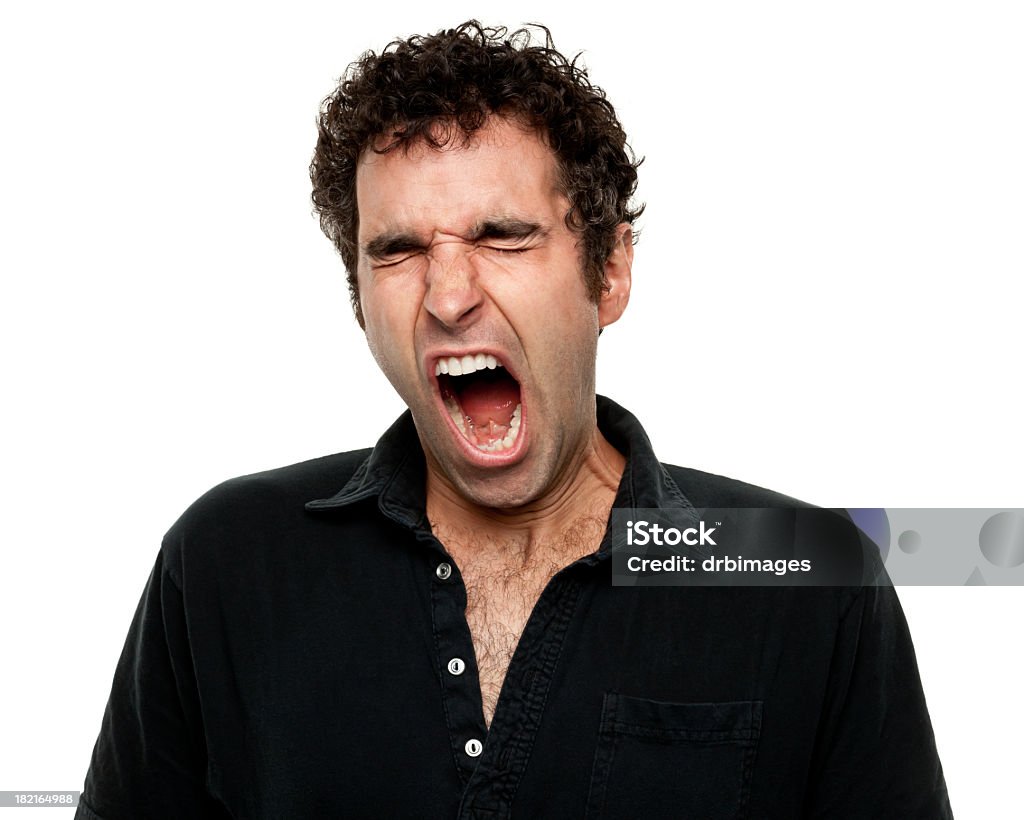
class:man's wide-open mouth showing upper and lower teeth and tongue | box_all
[434,353,522,452]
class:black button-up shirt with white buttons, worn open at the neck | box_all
[77,398,951,820]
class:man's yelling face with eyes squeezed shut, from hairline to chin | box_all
[356,117,629,509]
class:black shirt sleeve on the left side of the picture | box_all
[75,550,229,820]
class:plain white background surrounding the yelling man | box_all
[0,1,1024,820]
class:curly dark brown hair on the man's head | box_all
[309,20,643,327]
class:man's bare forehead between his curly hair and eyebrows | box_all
[355,117,568,243]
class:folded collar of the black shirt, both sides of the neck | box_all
[306,395,693,551]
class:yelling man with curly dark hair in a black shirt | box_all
[79,23,949,820]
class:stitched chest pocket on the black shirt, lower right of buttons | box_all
[587,692,762,820]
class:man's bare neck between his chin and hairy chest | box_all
[427,425,626,563]
